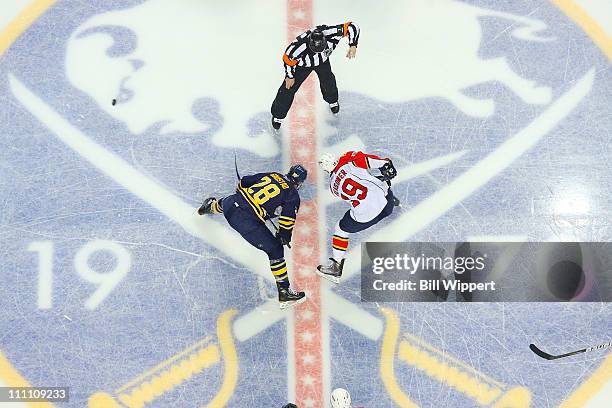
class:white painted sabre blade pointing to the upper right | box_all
[343,69,595,279]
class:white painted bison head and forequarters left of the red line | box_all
[66,0,280,158]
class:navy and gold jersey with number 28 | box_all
[237,172,300,240]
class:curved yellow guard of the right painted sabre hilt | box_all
[380,308,418,408]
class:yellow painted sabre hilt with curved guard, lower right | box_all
[380,309,531,408]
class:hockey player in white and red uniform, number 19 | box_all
[316,151,399,283]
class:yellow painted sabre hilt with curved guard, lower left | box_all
[88,310,238,408]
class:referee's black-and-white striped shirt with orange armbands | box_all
[283,21,359,78]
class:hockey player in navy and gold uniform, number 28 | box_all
[198,164,307,309]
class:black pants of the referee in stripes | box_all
[270,60,338,119]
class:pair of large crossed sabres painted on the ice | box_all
[9,42,595,408]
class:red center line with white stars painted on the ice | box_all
[287,0,324,408]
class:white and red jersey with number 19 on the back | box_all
[329,151,389,222]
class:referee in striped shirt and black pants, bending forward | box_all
[271,21,359,129]
